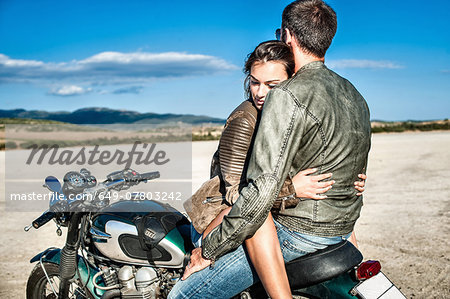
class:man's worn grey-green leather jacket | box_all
[202,61,371,260]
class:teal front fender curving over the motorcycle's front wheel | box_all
[30,248,105,298]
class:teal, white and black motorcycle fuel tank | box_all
[90,200,192,268]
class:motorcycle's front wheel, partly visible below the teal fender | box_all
[27,263,93,299]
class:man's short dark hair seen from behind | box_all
[281,0,337,58]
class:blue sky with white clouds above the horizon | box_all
[0,0,450,120]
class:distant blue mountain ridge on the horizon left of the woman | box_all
[0,107,225,125]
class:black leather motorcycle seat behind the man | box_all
[286,241,363,289]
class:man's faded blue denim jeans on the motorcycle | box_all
[169,221,350,299]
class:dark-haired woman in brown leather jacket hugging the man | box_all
[185,41,365,298]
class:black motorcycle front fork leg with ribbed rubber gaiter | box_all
[58,212,83,299]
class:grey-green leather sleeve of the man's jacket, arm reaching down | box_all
[202,88,305,260]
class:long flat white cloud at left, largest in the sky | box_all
[0,52,238,84]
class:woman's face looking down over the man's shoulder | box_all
[250,61,288,110]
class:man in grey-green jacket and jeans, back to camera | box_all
[170,0,370,298]
